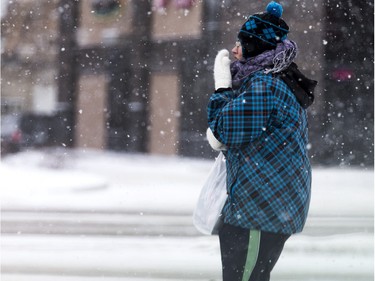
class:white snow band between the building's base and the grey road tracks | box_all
[0,150,374,217]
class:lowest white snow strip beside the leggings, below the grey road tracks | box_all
[2,234,373,281]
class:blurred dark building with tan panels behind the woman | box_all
[1,0,373,165]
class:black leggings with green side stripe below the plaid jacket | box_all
[219,224,290,281]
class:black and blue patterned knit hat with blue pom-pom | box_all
[238,1,289,58]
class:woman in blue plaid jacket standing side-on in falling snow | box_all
[207,2,316,281]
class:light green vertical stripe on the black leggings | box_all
[242,230,260,281]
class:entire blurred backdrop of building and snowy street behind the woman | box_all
[0,0,374,281]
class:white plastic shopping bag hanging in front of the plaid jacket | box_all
[193,152,228,235]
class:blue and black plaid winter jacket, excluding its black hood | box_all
[208,71,311,234]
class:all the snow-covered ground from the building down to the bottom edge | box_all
[0,149,374,281]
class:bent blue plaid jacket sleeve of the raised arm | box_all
[207,78,273,148]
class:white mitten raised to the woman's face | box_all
[214,49,232,90]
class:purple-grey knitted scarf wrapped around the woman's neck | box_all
[230,39,297,89]
